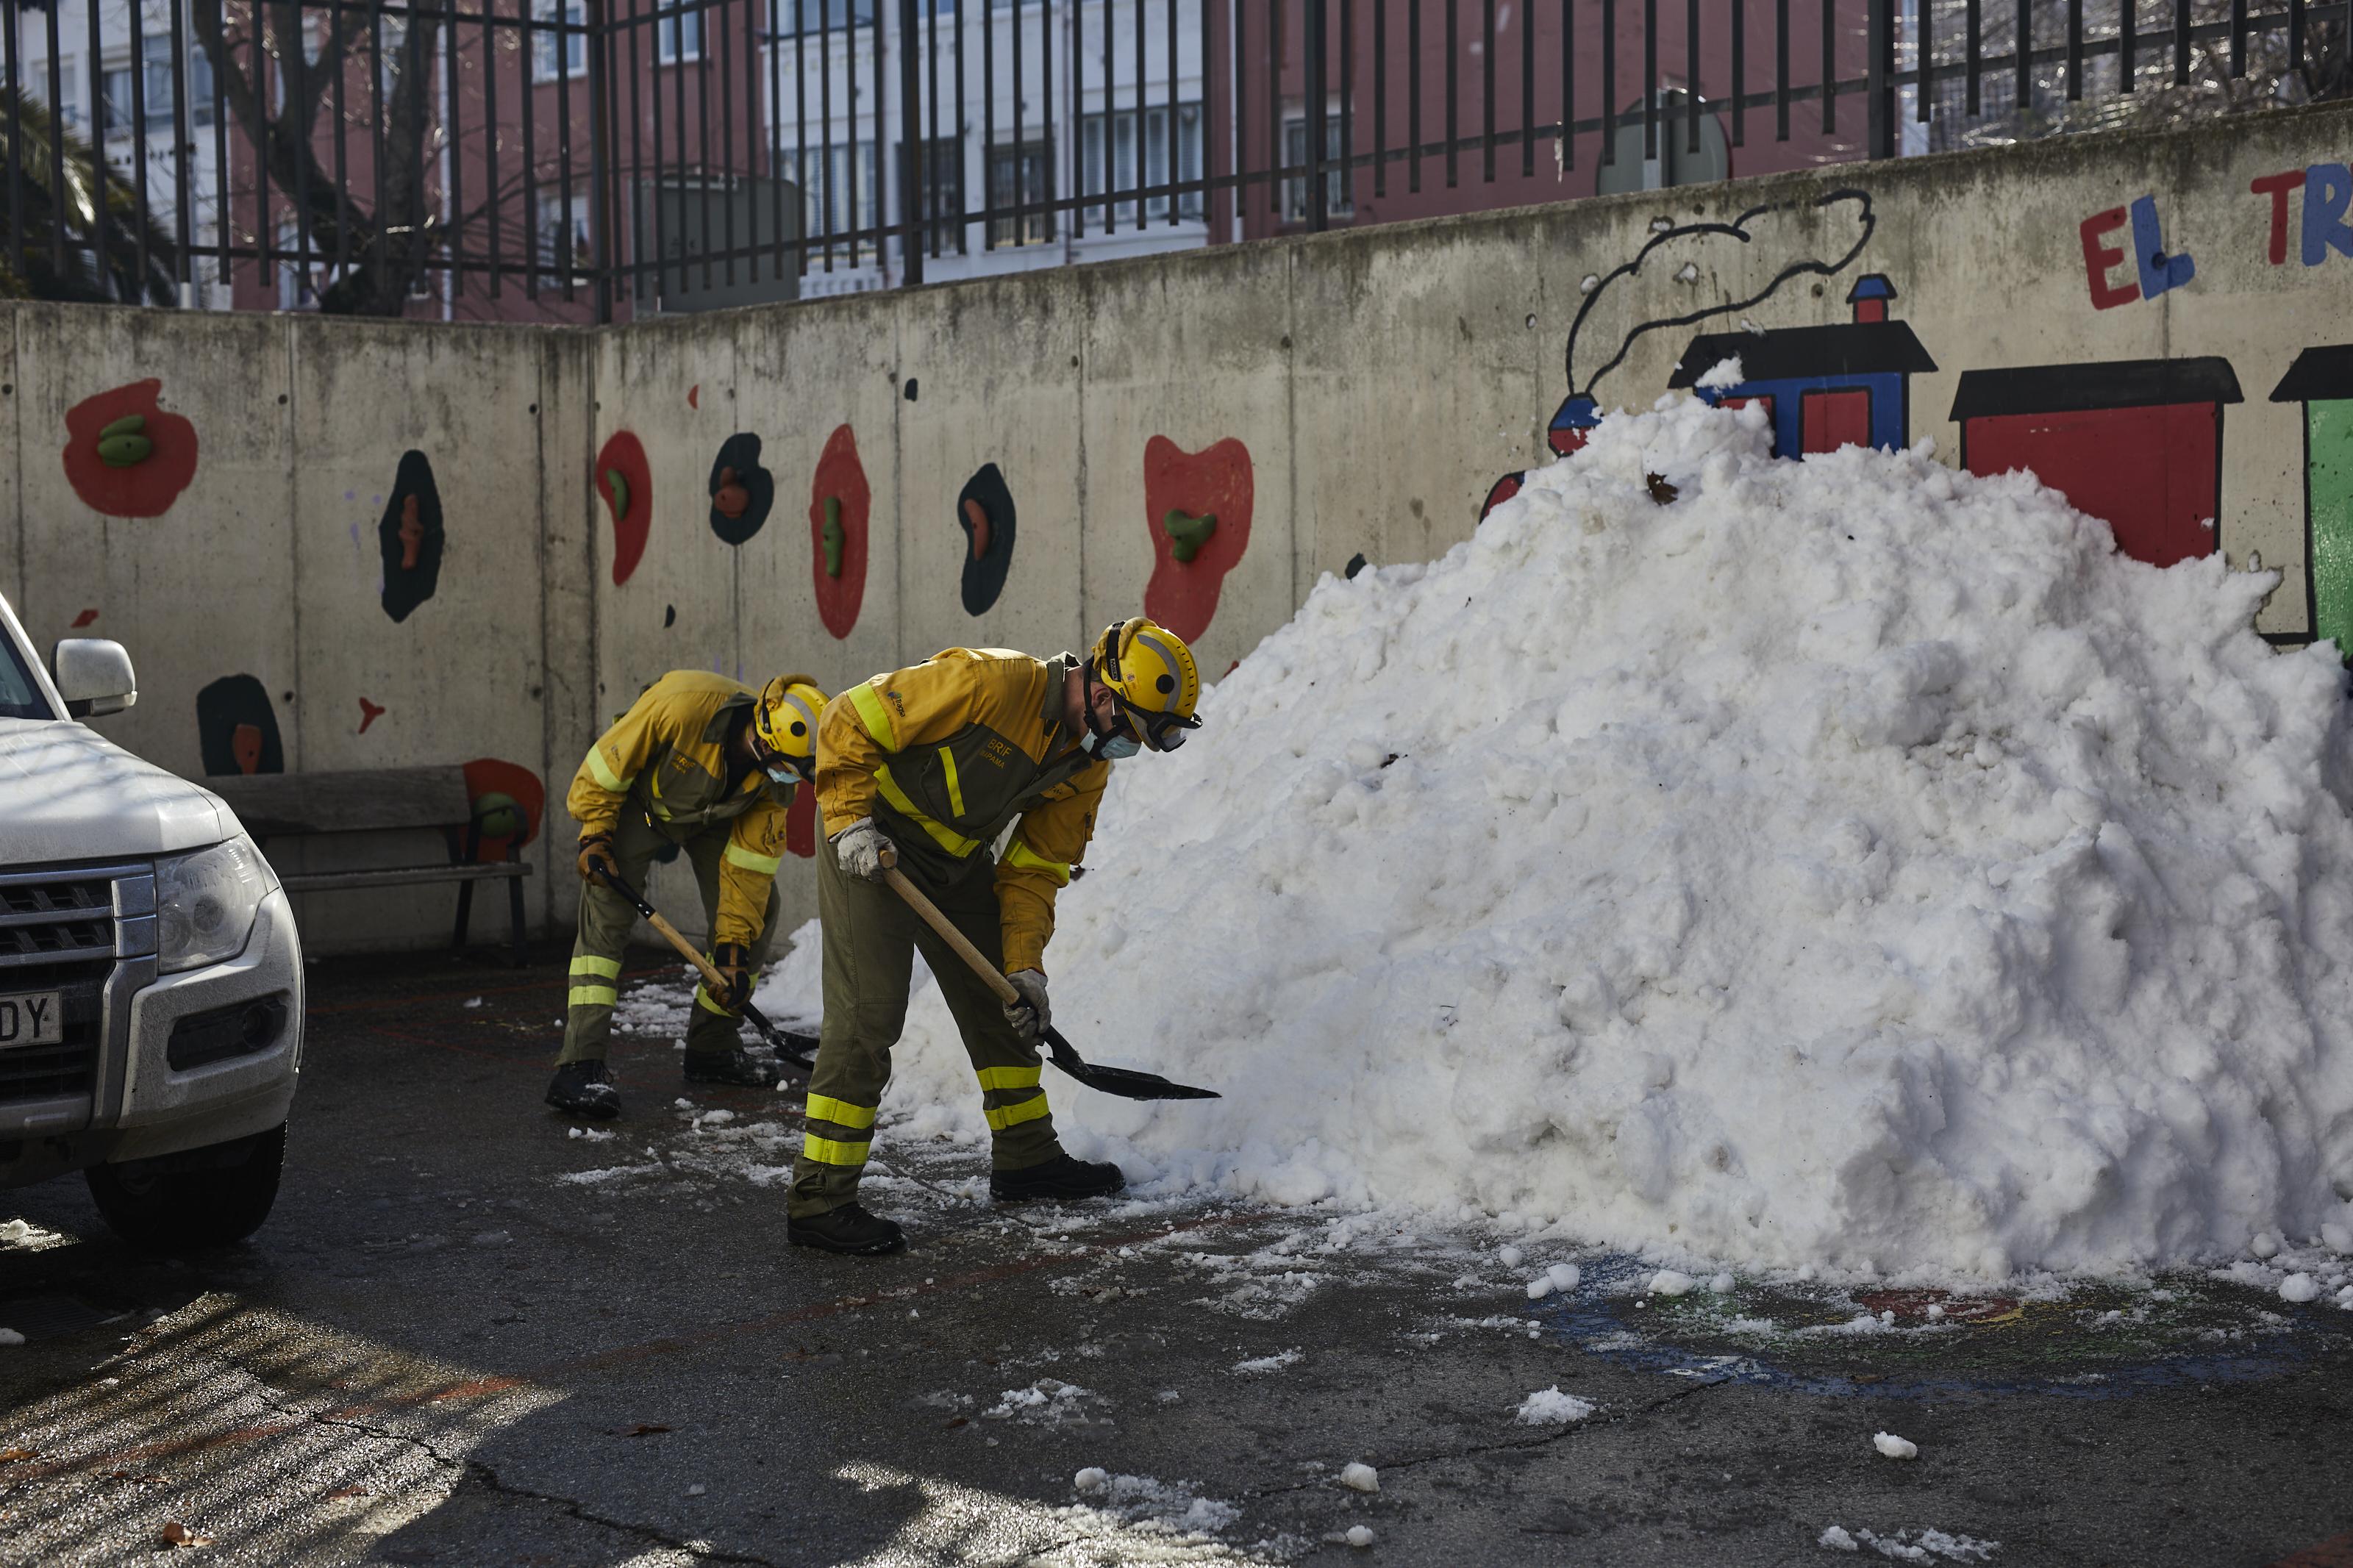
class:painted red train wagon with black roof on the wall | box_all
[1953,357,2243,567]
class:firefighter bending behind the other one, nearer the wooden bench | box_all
[549,670,826,1121]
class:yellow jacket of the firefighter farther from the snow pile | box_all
[565,670,807,945]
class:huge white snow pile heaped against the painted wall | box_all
[795,400,2353,1276]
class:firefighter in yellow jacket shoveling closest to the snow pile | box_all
[786,616,1200,1253]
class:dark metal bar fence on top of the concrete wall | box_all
[0,0,2353,320]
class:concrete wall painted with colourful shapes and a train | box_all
[0,110,2353,948]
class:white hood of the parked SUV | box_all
[0,720,238,872]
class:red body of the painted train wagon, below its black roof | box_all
[1963,402,2221,567]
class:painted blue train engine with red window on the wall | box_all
[1668,273,1937,459]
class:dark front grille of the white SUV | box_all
[0,867,132,1103]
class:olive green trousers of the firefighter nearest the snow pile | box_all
[786,844,1061,1218]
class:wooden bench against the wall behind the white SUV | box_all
[202,764,532,969]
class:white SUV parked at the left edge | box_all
[0,597,304,1250]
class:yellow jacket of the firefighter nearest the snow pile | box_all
[816,649,1110,973]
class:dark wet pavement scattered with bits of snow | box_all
[0,954,2353,1568]
